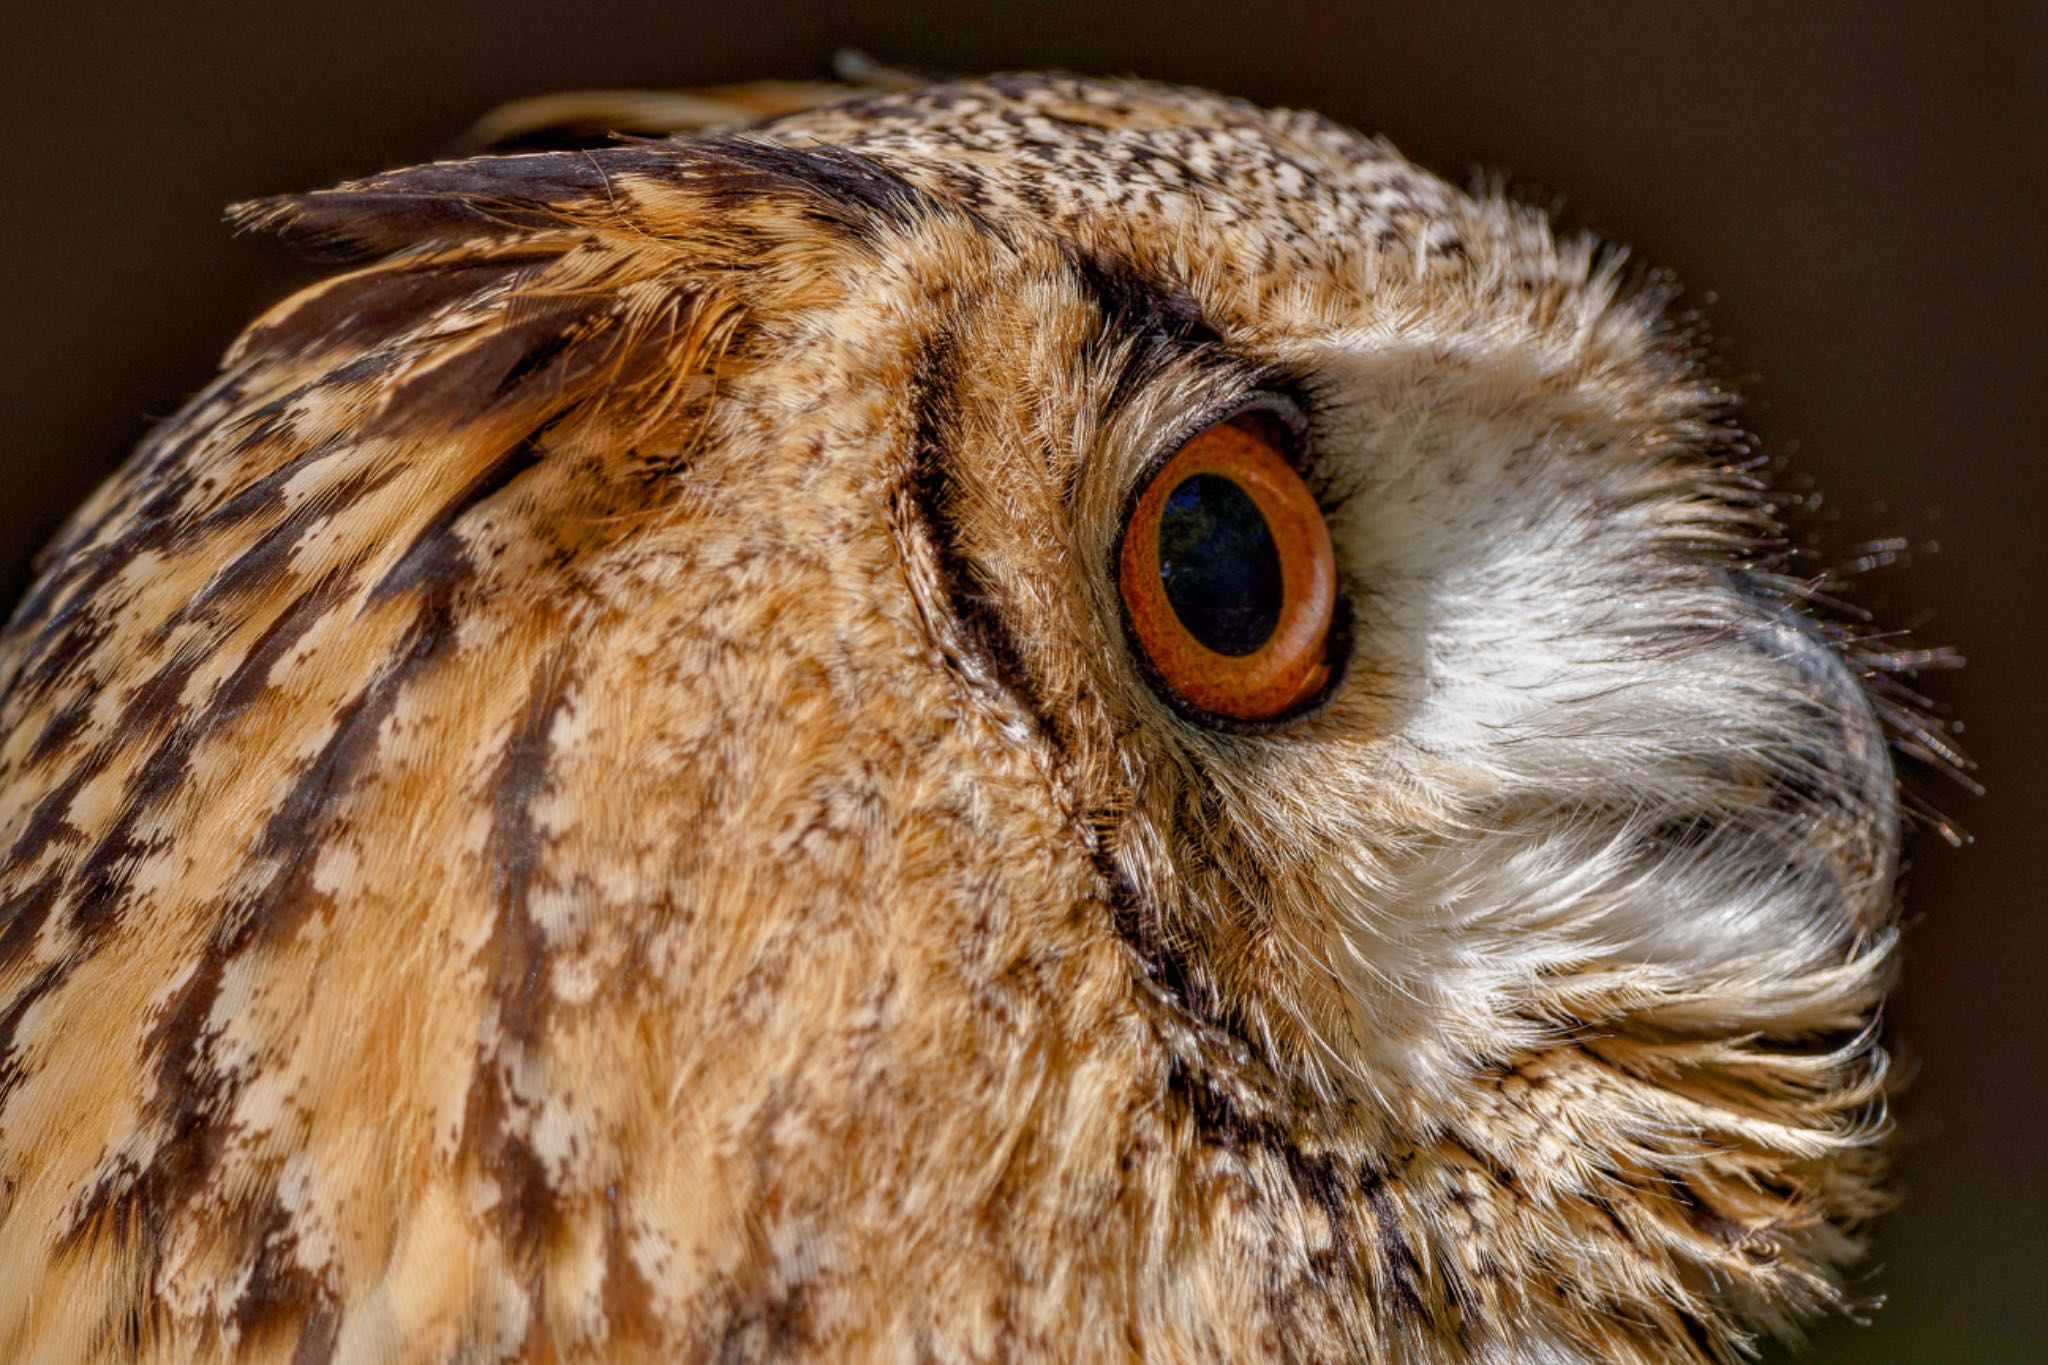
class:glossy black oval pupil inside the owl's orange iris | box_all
[1159,475,1282,655]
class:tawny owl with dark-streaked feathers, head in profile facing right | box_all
[0,66,1935,1365]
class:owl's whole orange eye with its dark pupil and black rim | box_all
[1116,413,1337,722]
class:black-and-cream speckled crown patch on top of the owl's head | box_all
[764,76,1470,296]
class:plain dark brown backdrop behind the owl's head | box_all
[0,0,2048,1361]
